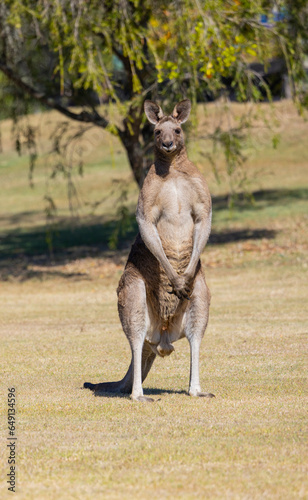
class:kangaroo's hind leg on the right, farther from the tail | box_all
[185,271,214,398]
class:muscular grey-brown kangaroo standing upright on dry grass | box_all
[84,99,214,401]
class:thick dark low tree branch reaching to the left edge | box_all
[0,61,118,129]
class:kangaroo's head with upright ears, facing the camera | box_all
[144,99,191,156]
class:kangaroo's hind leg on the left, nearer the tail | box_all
[118,273,156,401]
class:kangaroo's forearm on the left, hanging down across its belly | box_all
[137,218,177,281]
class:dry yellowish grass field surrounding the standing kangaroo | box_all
[0,101,308,500]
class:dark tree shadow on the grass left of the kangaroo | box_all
[0,215,137,281]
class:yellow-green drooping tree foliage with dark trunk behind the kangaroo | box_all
[0,0,308,193]
